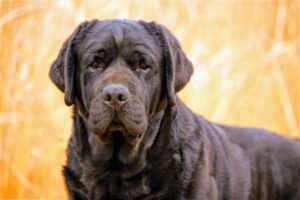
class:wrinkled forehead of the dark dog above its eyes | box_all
[78,20,161,59]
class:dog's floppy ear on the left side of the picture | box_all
[49,20,96,106]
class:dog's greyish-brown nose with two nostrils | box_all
[102,84,129,106]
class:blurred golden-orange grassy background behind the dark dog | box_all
[0,0,300,199]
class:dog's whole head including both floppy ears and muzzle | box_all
[49,20,193,166]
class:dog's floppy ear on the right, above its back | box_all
[141,21,193,107]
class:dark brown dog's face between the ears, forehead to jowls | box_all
[76,21,162,145]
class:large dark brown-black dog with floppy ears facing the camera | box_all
[50,20,300,200]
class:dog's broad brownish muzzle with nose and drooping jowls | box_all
[89,84,147,145]
